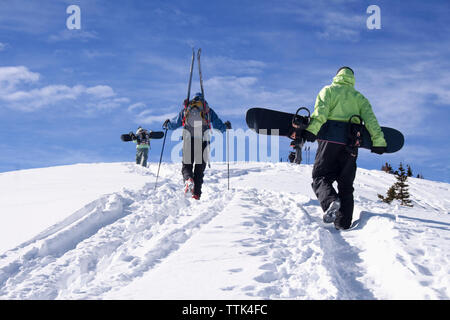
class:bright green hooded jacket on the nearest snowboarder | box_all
[307,69,387,147]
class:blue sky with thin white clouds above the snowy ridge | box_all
[0,0,450,182]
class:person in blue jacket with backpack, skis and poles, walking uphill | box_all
[163,93,231,200]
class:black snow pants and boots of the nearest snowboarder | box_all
[312,141,358,229]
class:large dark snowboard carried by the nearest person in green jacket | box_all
[246,108,405,153]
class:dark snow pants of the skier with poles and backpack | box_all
[181,139,208,196]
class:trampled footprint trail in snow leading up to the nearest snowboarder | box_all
[224,189,373,299]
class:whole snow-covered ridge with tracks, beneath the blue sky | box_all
[0,163,450,299]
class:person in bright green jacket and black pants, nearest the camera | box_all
[302,67,387,230]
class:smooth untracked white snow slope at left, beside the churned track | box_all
[0,163,150,252]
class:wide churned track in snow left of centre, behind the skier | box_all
[0,165,229,299]
